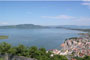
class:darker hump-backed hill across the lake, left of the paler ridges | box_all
[0,24,49,29]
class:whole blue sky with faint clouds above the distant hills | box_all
[0,0,90,26]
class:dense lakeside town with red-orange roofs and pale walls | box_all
[48,33,90,58]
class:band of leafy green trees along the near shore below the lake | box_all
[0,42,68,60]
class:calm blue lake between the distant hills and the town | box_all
[0,29,83,49]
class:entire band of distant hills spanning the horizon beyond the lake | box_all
[0,24,90,29]
